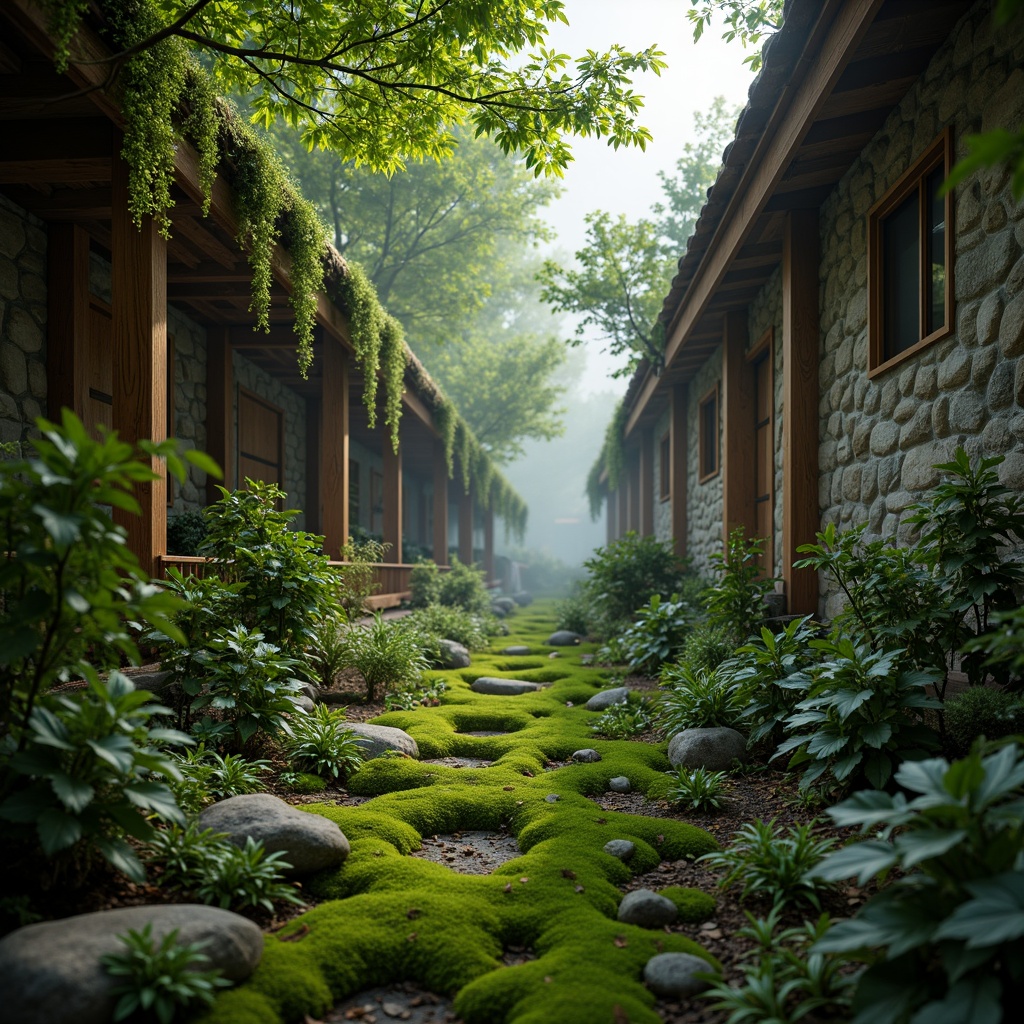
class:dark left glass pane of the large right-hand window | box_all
[882,191,922,359]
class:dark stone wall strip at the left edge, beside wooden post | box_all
[0,196,46,441]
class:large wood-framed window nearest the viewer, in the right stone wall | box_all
[867,129,953,376]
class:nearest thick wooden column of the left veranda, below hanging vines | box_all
[111,148,167,574]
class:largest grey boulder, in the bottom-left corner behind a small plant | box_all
[0,903,263,1024]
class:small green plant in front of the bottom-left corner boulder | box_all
[99,924,231,1024]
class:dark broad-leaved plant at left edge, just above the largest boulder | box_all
[0,668,191,882]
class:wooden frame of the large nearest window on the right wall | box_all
[867,128,955,378]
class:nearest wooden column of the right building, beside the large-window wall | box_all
[782,203,819,614]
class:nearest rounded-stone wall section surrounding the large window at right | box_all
[819,3,1024,614]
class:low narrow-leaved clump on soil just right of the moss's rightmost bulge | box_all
[699,818,836,909]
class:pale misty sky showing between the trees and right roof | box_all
[547,0,754,394]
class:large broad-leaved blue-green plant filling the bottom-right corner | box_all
[814,744,1024,1024]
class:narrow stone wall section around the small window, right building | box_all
[686,345,722,575]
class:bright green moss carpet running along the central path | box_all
[195,602,716,1024]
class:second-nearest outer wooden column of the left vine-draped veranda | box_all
[319,334,350,558]
